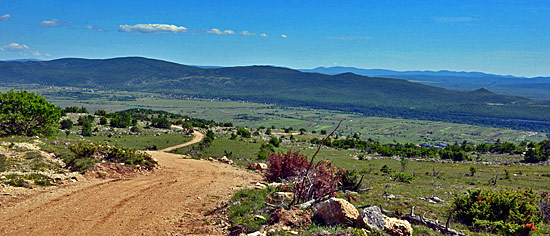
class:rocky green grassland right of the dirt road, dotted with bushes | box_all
[183,130,550,235]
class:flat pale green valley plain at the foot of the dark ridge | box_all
[7,87,547,144]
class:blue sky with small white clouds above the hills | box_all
[0,0,550,77]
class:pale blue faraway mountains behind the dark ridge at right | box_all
[300,66,550,100]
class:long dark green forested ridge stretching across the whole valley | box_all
[0,57,550,131]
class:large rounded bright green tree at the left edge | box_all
[0,89,61,136]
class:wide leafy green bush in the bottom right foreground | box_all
[453,189,543,235]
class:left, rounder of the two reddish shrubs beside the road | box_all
[266,150,309,182]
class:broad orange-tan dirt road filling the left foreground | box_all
[0,131,260,235]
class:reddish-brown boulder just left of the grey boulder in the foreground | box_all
[313,198,359,225]
